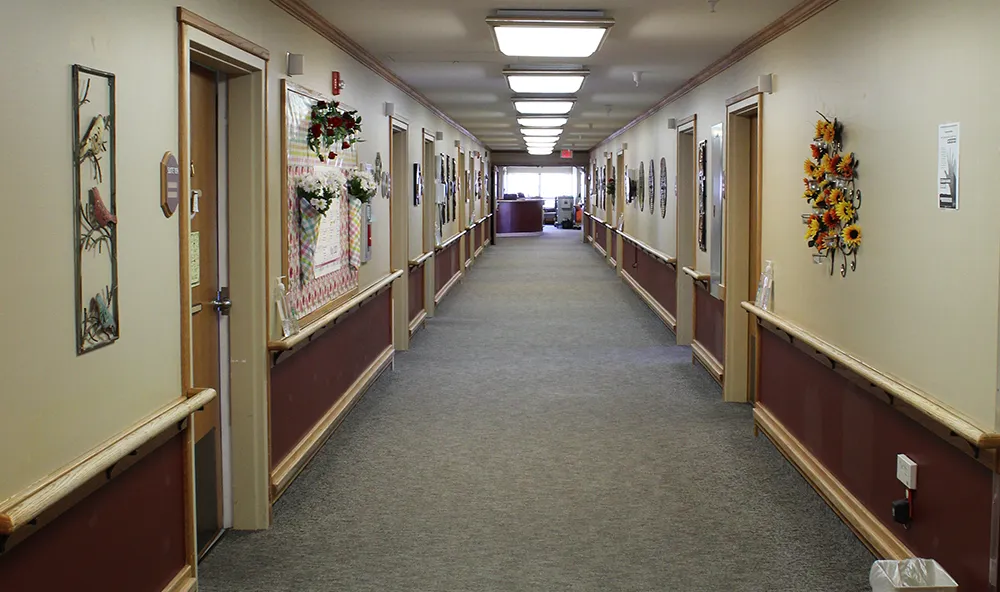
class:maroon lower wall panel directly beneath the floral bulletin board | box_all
[271,289,392,469]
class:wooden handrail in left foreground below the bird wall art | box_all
[0,389,216,535]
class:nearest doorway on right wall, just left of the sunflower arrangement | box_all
[723,94,761,402]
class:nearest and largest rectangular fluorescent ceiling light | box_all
[486,10,615,58]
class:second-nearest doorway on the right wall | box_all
[674,116,698,345]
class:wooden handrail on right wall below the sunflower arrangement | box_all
[742,302,1000,449]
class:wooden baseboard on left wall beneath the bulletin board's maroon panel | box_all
[271,345,395,503]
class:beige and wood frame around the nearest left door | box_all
[176,8,271,556]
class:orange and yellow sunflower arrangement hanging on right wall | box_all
[802,113,861,277]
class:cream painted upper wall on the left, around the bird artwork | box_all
[0,0,479,500]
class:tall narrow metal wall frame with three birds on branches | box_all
[72,65,119,354]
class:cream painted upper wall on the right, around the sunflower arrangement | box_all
[594,0,1000,430]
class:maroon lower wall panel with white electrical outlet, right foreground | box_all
[758,328,993,591]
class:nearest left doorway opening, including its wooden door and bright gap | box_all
[189,63,231,557]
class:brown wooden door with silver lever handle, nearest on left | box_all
[190,64,222,555]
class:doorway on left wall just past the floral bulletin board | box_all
[389,118,412,351]
